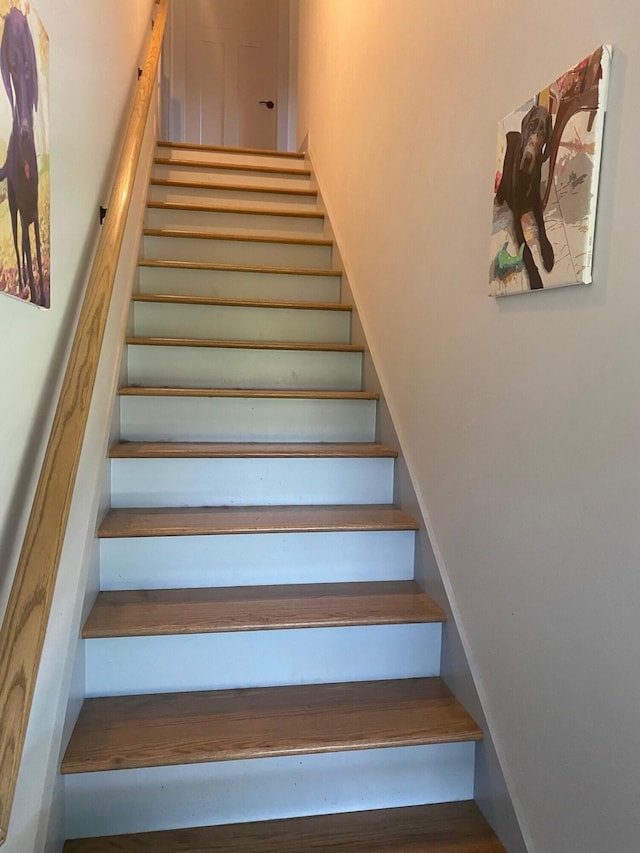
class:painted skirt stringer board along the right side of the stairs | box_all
[305,150,528,853]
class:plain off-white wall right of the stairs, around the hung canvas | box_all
[298,0,640,853]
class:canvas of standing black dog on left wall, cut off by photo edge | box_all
[0,0,50,308]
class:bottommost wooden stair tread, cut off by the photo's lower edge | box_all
[63,800,506,853]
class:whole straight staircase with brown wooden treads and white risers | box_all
[62,144,504,853]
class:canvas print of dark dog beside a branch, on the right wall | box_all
[490,45,611,296]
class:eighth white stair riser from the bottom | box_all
[138,266,340,302]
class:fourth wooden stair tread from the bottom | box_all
[98,504,418,539]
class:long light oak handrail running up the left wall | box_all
[0,0,169,844]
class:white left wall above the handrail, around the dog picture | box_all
[0,0,153,612]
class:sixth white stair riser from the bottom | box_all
[127,345,362,391]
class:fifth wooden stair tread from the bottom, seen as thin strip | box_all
[109,441,398,459]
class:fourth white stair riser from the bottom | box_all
[111,459,394,507]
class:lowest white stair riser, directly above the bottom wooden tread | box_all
[65,743,475,838]
